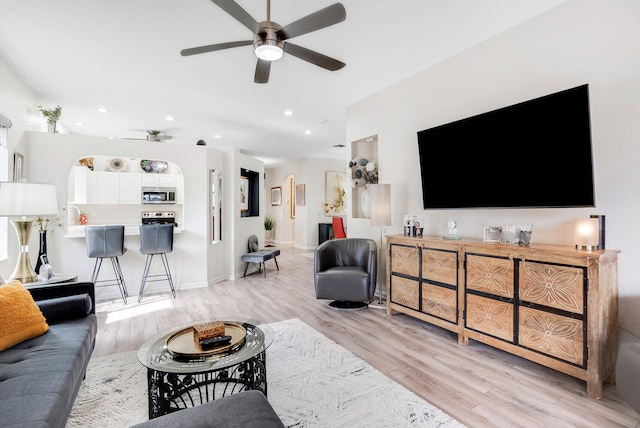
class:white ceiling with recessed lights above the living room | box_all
[0,0,565,166]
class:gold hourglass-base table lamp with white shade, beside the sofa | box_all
[0,182,58,283]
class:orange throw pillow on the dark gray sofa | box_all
[0,280,49,351]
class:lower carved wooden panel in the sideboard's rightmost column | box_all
[519,306,584,365]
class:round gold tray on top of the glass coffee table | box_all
[166,322,247,360]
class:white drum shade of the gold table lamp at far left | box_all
[0,182,58,217]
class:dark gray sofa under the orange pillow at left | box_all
[0,282,97,428]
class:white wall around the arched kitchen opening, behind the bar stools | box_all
[10,132,239,298]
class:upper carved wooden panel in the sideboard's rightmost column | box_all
[520,262,584,314]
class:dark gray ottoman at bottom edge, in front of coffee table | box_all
[134,391,284,428]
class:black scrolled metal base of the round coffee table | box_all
[147,351,267,419]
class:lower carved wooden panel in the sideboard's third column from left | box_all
[466,294,513,342]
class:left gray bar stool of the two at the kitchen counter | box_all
[84,225,129,304]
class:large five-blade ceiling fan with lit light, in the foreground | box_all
[180,0,347,83]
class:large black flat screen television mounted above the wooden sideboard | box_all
[418,85,595,209]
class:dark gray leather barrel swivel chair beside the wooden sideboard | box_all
[314,238,378,309]
